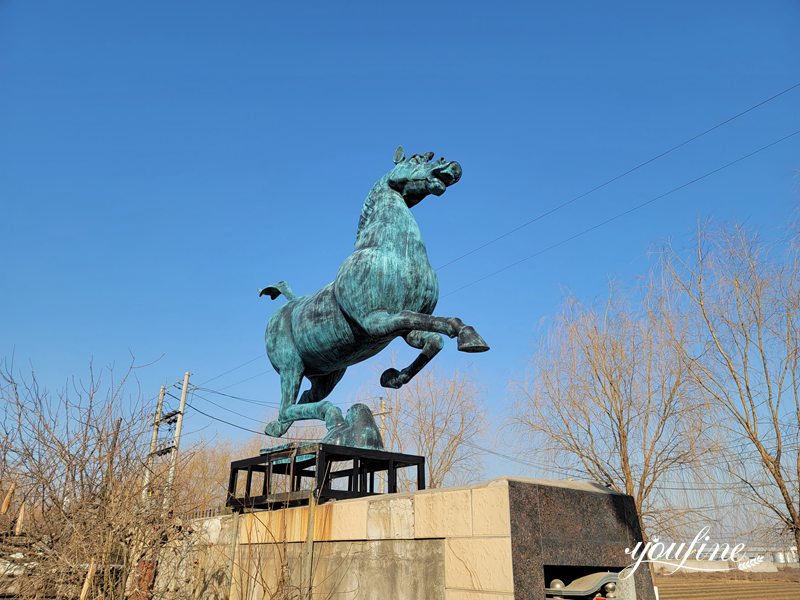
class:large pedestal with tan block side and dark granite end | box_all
[159,478,653,600]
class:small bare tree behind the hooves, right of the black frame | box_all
[376,369,486,488]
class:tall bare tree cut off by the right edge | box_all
[665,227,800,547]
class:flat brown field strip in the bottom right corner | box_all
[656,569,800,600]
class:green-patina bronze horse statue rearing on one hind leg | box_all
[260,147,489,447]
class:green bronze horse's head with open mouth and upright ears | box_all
[387,146,461,208]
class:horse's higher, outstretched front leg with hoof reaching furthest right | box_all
[360,310,489,352]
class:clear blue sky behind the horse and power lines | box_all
[0,0,800,468]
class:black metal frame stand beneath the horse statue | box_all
[226,443,425,512]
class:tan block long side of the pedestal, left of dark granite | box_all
[231,480,514,600]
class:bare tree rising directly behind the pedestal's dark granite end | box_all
[512,286,698,534]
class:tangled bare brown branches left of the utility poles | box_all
[0,360,203,600]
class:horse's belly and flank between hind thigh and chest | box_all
[292,284,390,374]
